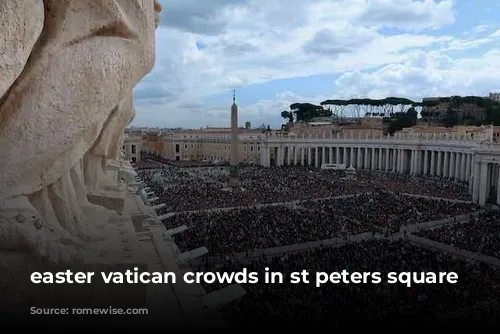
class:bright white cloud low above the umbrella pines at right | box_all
[335,49,500,99]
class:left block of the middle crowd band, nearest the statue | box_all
[164,206,372,256]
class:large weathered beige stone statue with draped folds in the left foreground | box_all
[0,0,161,262]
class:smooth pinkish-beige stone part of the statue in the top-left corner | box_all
[0,0,44,103]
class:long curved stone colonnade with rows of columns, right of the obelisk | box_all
[260,137,500,205]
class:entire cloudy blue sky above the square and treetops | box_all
[131,0,500,128]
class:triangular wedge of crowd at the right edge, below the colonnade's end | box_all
[416,212,500,258]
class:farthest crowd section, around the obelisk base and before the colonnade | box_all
[137,160,470,211]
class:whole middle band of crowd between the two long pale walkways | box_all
[163,191,477,256]
